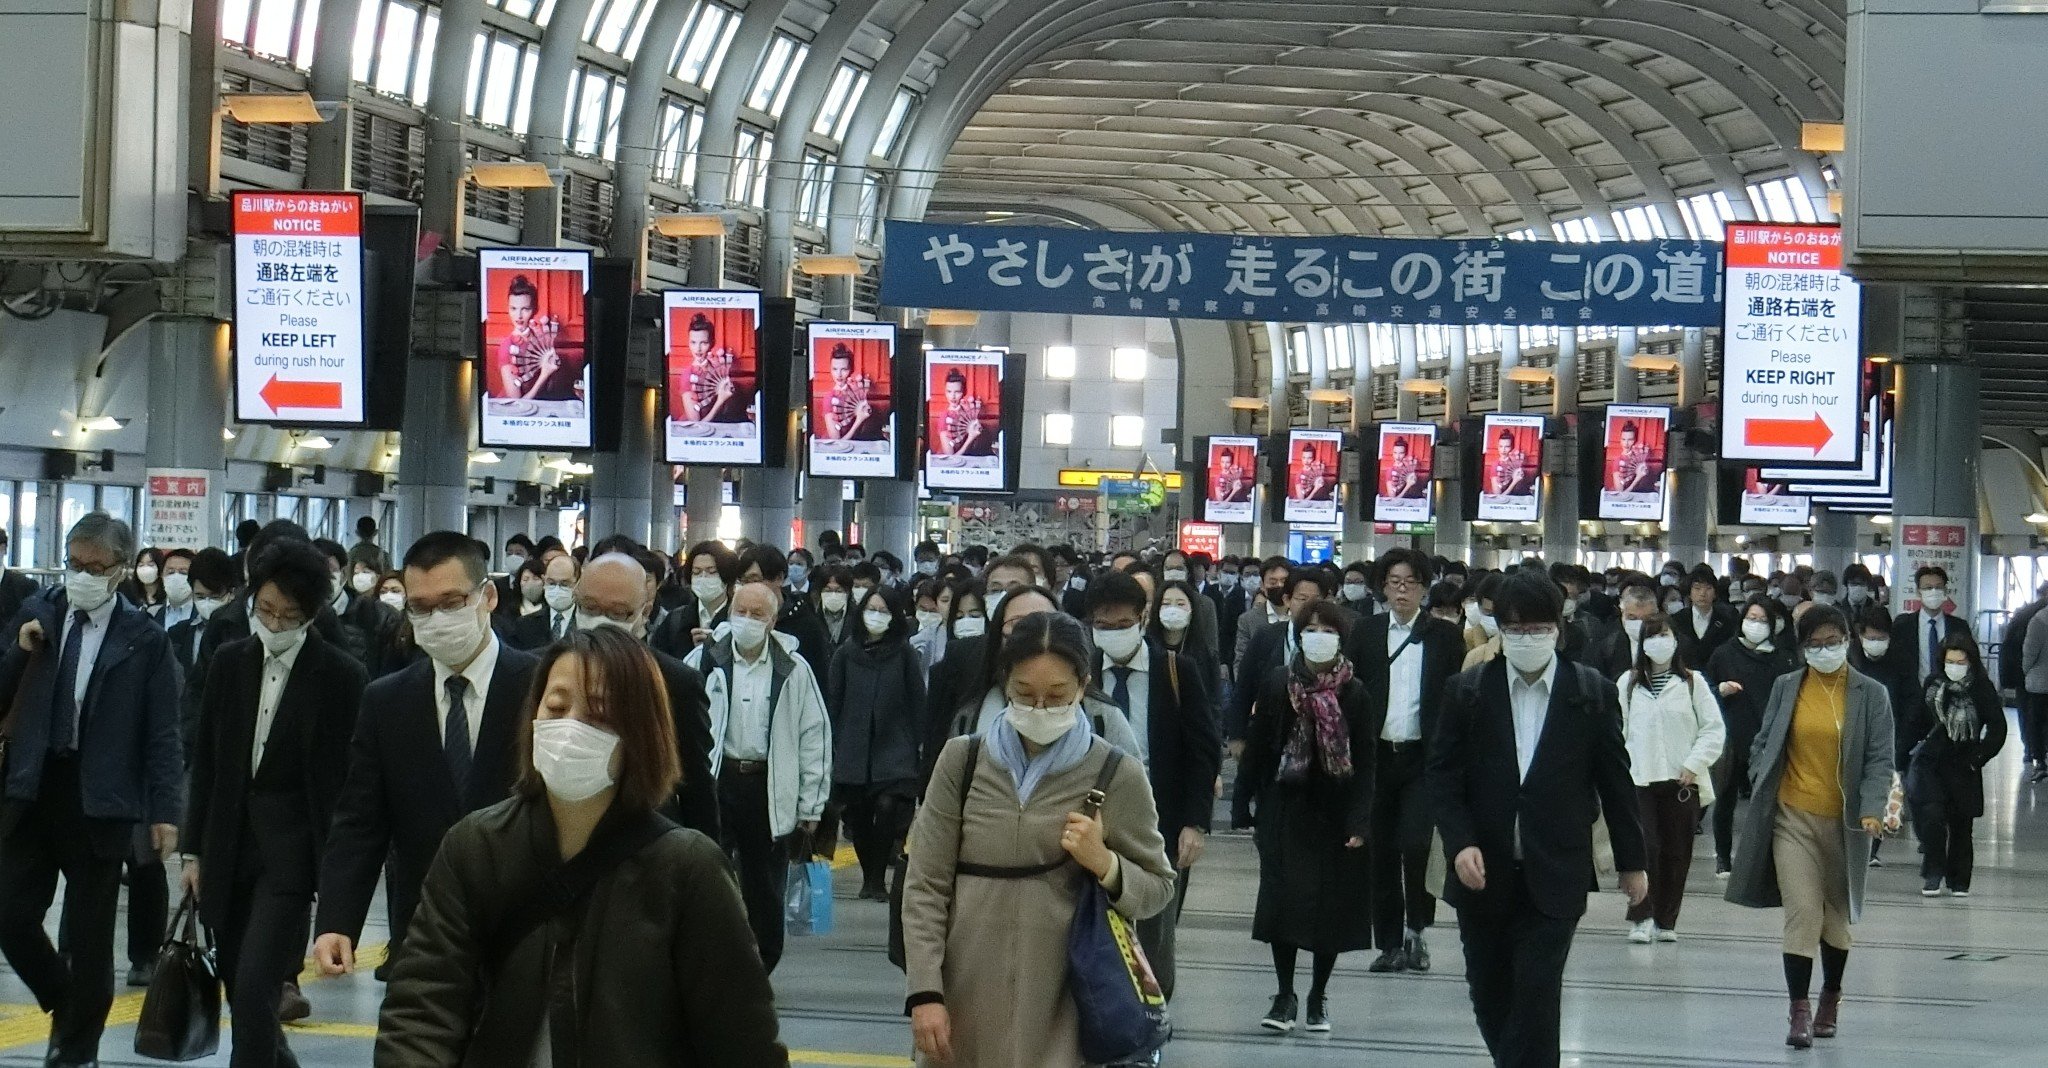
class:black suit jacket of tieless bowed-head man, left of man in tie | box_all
[178,633,369,929]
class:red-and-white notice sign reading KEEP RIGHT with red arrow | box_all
[1720,223,1864,463]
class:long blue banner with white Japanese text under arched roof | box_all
[881,221,1722,326]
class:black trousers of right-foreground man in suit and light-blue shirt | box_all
[1458,867,1579,1068]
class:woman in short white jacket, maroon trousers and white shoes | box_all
[1618,613,1726,945]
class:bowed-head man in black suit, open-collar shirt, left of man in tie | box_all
[182,541,369,1066]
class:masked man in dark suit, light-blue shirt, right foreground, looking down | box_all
[1427,572,1649,1068]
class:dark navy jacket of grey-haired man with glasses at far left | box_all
[0,590,184,832]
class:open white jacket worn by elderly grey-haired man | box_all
[682,627,831,838]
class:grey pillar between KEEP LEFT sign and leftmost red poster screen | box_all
[391,359,477,545]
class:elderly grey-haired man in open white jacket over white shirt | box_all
[684,582,831,972]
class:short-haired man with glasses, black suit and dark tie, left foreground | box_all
[313,531,539,974]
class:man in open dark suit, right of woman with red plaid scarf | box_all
[1348,549,1464,972]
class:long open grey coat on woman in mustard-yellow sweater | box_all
[1726,668,1892,922]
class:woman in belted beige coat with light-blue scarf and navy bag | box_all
[903,613,1174,1068]
